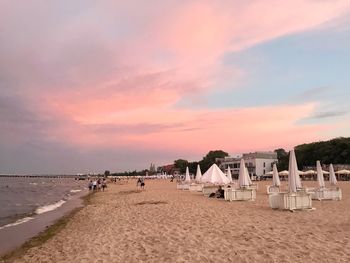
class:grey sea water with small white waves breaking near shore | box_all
[0,177,88,228]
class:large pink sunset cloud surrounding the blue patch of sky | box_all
[0,0,350,169]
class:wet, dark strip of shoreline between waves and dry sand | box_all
[0,190,92,262]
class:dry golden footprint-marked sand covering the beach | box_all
[9,180,350,262]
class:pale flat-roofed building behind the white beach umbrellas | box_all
[216,152,278,178]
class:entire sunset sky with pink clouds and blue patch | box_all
[0,0,350,174]
